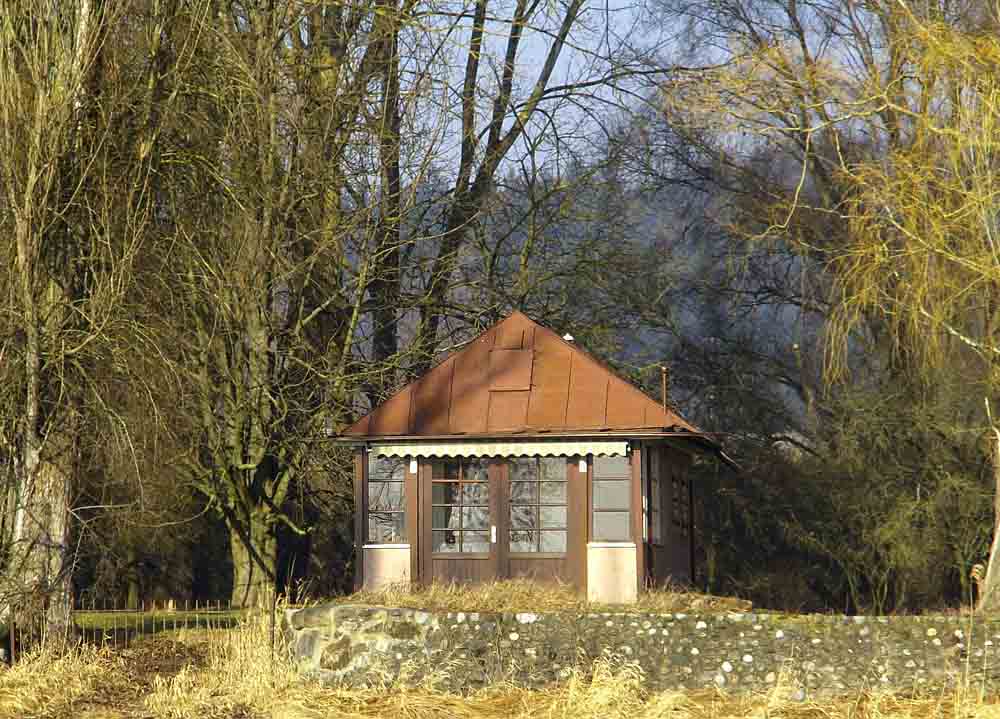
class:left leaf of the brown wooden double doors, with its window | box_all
[418,458,506,584]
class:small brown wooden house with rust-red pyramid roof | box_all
[340,312,719,603]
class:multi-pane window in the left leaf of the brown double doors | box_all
[431,459,490,554]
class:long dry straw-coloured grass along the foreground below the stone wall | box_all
[0,617,1000,719]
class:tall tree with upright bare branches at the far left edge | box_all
[0,0,199,639]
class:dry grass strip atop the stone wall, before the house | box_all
[333,579,751,614]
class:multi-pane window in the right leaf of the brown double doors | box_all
[507,457,567,554]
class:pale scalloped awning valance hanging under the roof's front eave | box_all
[370,440,628,457]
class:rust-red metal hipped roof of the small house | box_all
[342,312,707,439]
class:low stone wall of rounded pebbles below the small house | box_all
[285,605,1000,697]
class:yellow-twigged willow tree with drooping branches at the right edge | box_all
[666,0,1000,609]
